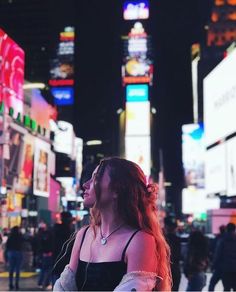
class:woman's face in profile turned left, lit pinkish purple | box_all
[83,166,114,208]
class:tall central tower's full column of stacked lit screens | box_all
[122,0,153,176]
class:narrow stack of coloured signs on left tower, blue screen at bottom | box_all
[49,27,75,106]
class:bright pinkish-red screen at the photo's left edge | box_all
[0,29,24,112]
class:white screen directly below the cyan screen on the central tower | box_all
[125,101,150,136]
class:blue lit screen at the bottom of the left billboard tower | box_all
[51,87,74,105]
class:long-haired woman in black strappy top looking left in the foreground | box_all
[54,157,171,291]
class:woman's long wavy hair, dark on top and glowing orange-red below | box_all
[91,157,171,291]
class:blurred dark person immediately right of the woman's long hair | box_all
[164,216,181,291]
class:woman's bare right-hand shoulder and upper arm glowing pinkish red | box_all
[126,231,157,272]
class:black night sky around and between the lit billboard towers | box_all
[0,0,211,214]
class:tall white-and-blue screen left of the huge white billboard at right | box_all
[182,124,205,188]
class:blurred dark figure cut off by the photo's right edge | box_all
[214,223,236,291]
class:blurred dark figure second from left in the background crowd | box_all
[37,222,53,289]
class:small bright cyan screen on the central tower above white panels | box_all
[126,84,148,102]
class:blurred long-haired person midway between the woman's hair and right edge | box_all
[184,230,209,291]
